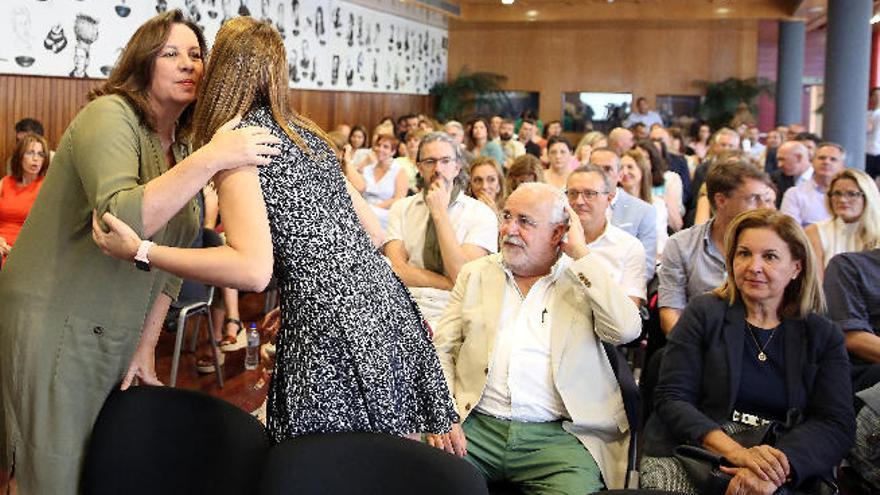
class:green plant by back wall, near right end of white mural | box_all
[431,66,507,122]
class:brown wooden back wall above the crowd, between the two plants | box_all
[449,20,758,127]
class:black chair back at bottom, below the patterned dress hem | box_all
[260,433,488,495]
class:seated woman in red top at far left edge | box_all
[0,133,49,261]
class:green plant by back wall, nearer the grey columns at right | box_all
[697,77,774,129]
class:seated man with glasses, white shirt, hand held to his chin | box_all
[384,132,498,327]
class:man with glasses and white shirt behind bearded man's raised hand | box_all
[565,165,645,308]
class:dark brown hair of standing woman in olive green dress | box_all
[89,9,208,136]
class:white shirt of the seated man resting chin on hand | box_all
[385,193,498,326]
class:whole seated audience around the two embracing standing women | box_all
[0,110,880,494]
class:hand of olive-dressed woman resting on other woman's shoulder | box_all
[198,115,281,172]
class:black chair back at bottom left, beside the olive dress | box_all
[81,387,270,495]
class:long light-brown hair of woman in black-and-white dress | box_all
[193,17,331,153]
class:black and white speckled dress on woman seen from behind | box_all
[242,106,457,441]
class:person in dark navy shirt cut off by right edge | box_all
[824,252,880,392]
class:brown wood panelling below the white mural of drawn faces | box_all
[0,74,433,161]
